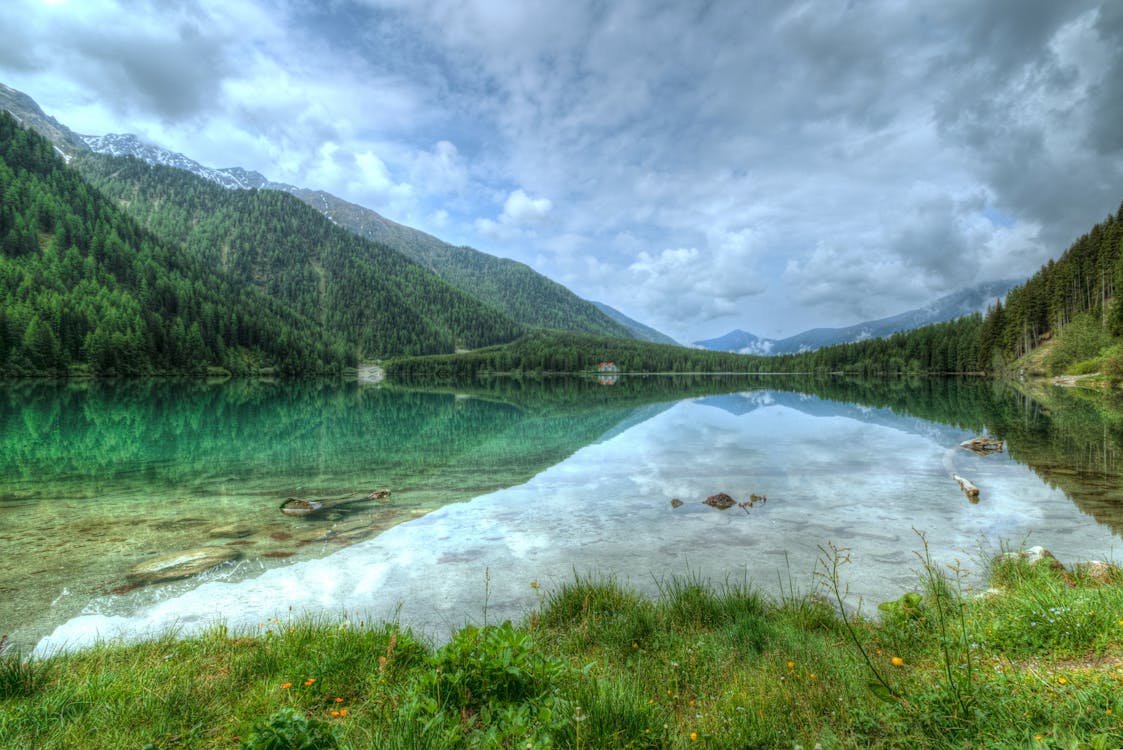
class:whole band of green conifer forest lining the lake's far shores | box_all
[0,104,1123,382]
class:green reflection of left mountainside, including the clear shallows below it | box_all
[0,378,786,646]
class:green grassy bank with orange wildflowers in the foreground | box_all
[0,550,1123,750]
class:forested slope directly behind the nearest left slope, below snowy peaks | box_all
[74,155,521,358]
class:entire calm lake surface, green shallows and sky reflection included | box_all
[0,378,1123,653]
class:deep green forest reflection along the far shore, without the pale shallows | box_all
[0,375,1123,506]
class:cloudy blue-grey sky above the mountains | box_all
[0,0,1123,341]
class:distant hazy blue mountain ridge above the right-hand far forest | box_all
[694,278,1021,355]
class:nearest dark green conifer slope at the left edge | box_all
[0,112,349,374]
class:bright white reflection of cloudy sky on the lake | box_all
[32,394,1114,650]
